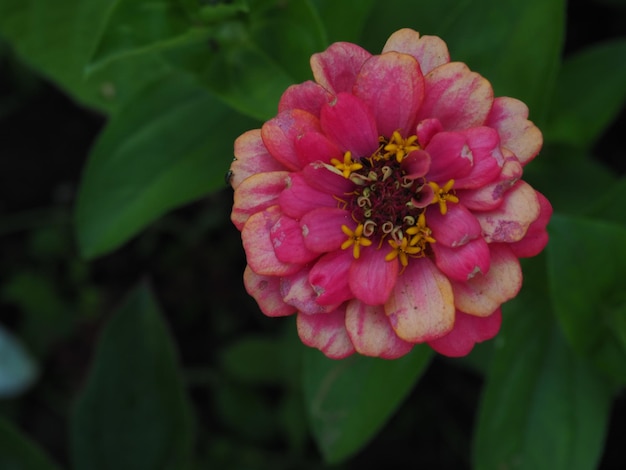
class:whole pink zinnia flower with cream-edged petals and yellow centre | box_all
[231,29,552,358]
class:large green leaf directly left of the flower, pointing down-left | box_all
[75,76,254,257]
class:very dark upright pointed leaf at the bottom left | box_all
[71,285,193,470]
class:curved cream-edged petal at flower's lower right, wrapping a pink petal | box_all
[452,243,522,317]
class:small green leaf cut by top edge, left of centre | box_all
[89,0,212,69]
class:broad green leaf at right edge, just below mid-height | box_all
[548,215,626,384]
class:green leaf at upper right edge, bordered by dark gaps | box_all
[545,39,626,148]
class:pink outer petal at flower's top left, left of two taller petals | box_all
[311,42,372,94]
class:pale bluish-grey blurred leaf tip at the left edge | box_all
[0,325,39,398]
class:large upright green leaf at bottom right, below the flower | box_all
[473,258,613,470]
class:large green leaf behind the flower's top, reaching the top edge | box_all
[363,0,565,124]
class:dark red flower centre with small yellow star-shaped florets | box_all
[331,131,459,268]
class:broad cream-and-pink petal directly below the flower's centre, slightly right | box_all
[385,258,454,343]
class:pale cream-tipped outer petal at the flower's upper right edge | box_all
[487,97,543,166]
